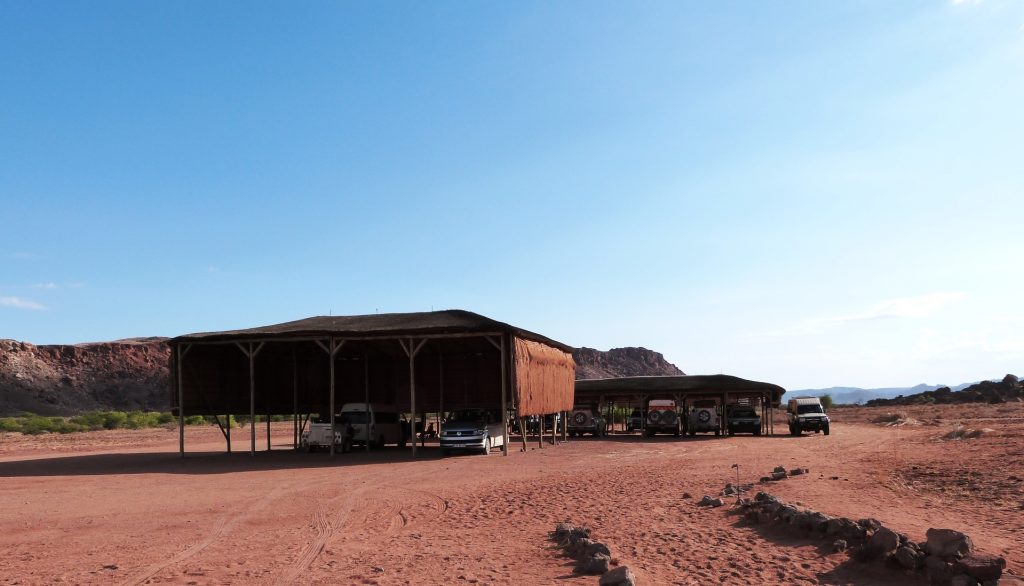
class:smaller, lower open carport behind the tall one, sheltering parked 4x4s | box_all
[575,374,785,434]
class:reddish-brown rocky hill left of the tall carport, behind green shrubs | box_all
[0,338,170,415]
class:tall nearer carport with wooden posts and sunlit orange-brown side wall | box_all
[169,309,575,457]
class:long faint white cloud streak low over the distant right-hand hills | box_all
[744,293,965,341]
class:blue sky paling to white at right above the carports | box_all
[0,0,1024,388]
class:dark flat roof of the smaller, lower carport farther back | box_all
[575,374,785,405]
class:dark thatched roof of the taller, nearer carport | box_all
[170,309,573,352]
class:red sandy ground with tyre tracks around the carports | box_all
[0,404,1024,585]
